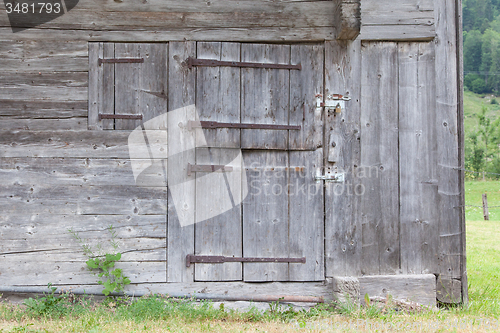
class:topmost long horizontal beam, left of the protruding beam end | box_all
[0,0,335,30]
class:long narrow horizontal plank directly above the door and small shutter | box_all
[0,26,334,42]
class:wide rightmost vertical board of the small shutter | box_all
[140,43,168,129]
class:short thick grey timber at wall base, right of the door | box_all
[358,274,436,307]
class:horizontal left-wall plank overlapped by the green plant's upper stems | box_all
[0,214,166,255]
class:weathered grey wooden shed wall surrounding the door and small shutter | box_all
[0,0,467,300]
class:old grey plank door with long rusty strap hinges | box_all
[189,43,324,281]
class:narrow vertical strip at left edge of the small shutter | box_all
[88,43,102,130]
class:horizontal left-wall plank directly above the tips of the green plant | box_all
[0,184,168,215]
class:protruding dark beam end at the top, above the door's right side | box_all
[333,0,361,40]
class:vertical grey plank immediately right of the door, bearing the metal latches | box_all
[325,40,365,276]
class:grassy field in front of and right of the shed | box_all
[0,181,500,333]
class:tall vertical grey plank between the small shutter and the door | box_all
[167,42,196,282]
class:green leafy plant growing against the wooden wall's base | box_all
[68,225,130,296]
